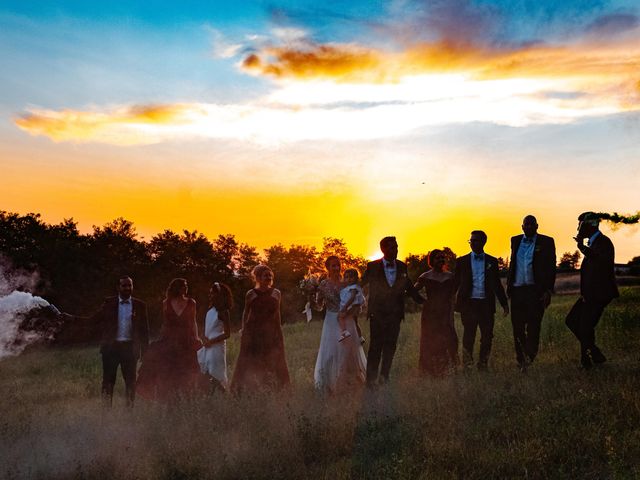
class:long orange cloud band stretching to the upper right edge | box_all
[241,41,640,90]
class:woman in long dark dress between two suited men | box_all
[415,250,458,377]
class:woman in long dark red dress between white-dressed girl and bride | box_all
[231,265,289,394]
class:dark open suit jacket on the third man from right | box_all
[454,253,508,313]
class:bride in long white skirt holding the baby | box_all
[313,255,367,394]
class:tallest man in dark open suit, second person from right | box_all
[507,215,556,371]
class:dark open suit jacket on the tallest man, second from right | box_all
[507,234,556,297]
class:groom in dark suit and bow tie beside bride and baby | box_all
[362,237,424,387]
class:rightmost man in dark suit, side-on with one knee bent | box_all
[565,212,619,369]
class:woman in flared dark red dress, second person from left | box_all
[137,278,202,400]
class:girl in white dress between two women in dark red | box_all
[198,282,233,392]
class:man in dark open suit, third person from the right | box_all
[454,230,509,370]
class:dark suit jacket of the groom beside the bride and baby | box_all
[362,259,424,322]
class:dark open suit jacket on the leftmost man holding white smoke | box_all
[93,296,149,358]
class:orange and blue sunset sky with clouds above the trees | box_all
[0,0,640,262]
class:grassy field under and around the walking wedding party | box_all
[0,287,640,480]
